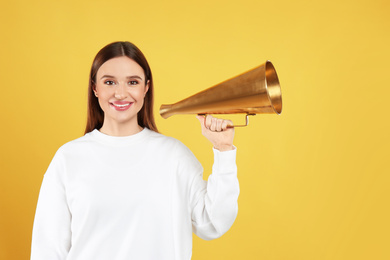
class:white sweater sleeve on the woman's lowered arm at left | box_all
[31,152,71,260]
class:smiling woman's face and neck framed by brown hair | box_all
[95,56,149,130]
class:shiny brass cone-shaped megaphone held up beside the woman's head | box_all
[160,61,282,126]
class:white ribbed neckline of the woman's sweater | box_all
[89,127,150,146]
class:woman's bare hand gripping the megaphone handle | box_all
[197,115,234,152]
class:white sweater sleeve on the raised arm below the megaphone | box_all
[190,149,240,240]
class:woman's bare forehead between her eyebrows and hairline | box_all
[97,56,145,78]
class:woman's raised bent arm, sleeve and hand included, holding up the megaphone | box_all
[191,116,240,240]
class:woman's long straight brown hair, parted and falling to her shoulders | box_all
[85,42,158,133]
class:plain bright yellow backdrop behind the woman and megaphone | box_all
[0,0,390,260]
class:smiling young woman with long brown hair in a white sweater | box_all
[31,42,239,260]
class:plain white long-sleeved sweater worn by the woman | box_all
[31,128,239,260]
